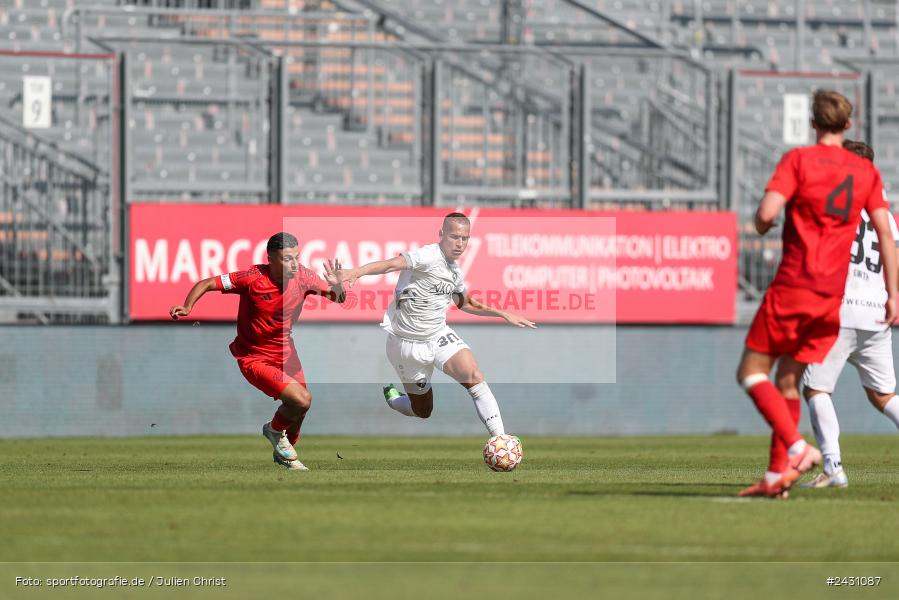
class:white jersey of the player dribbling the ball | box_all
[381,244,465,340]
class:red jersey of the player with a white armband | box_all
[215,265,330,363]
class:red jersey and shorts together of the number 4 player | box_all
[746,144,889,363]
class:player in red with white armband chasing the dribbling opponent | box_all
[169,232,346,471]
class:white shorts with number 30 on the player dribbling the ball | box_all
[387,327,468,394]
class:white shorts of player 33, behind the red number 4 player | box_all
[802,327,896,394]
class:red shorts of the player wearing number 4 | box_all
[746,285,843,363]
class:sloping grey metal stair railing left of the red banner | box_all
[0,117,120,323]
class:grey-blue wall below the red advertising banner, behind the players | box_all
[0,324,895,437]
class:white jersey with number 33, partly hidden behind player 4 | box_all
[840,210,899,331]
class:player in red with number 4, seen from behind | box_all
[737,90,899,497]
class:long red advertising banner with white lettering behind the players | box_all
[129,204,737,324]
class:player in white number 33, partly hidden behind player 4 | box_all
[802,140,899,488]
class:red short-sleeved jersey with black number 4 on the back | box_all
[766,144,888,296]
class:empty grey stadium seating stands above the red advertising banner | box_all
[0,0,899,324]
